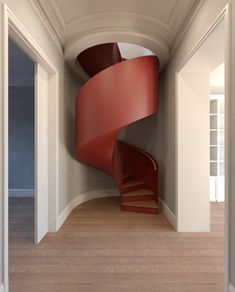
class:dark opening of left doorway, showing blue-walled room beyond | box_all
[8,39,35,245]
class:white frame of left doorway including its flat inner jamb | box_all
[0,4,59,291]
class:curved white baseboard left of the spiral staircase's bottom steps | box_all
[57,189,119,231]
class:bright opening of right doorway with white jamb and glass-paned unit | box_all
[177,19,225,232]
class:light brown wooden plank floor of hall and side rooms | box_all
[9,197,224,292]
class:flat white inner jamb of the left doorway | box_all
[35,64,48,243]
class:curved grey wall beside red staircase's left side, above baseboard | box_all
[59,66,116,212]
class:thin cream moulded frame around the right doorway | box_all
[175,3,230,291]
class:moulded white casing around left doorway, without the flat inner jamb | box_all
[0,4,59,292]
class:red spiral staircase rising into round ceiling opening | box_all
[76,43,159,214]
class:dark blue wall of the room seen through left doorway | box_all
[9,87,34,189]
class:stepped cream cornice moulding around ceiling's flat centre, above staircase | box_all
[34,0,200,74]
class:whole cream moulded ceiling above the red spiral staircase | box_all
[35,0,202,76]
